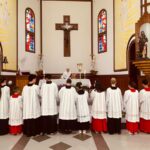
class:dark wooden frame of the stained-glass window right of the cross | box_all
[97,9,107,53]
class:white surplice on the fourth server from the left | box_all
[41,82,58,116]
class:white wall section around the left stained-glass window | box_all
[18,0,40,73]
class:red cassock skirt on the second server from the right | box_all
[126,120,139,133]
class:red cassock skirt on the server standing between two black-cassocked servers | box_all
[92,118,107,132]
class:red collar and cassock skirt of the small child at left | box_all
[9,94,22,135]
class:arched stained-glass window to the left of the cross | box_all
[25,8,35,53]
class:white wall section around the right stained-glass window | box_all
[93,0,128,75]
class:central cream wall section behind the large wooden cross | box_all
[42,1,91,73]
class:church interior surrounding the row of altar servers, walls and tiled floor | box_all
[0,0,150,150]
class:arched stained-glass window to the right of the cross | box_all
[98,9,107,53]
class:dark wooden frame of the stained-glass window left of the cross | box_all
[25,7,36,53]
